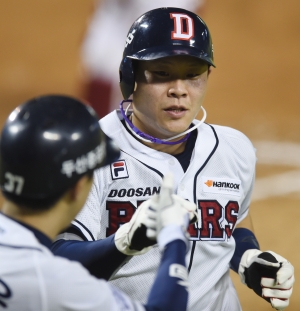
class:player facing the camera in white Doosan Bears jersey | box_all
[53,8,294,311]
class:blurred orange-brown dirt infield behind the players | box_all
[0,0,300,311]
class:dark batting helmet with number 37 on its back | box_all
[0,95,119,208]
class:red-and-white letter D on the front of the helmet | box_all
[170,13,194,40]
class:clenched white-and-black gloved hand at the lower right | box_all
[239,249,295,310]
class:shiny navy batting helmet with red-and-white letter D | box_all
[119,8,215,99]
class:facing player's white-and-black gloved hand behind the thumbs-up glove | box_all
[115,173,198,255]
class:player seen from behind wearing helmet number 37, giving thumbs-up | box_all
[0,95,196,311]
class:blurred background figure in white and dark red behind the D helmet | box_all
[81,0,206,117]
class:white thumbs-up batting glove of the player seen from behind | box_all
[146,174,198,252]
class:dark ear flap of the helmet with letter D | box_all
[119,57,134,99]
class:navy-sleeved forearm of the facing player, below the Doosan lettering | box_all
[51,235,130,280]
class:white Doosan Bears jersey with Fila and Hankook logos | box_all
[73,111,256,311]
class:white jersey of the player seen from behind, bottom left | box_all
[0,213,145,311]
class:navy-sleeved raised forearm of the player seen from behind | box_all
[145,240,188,311]
